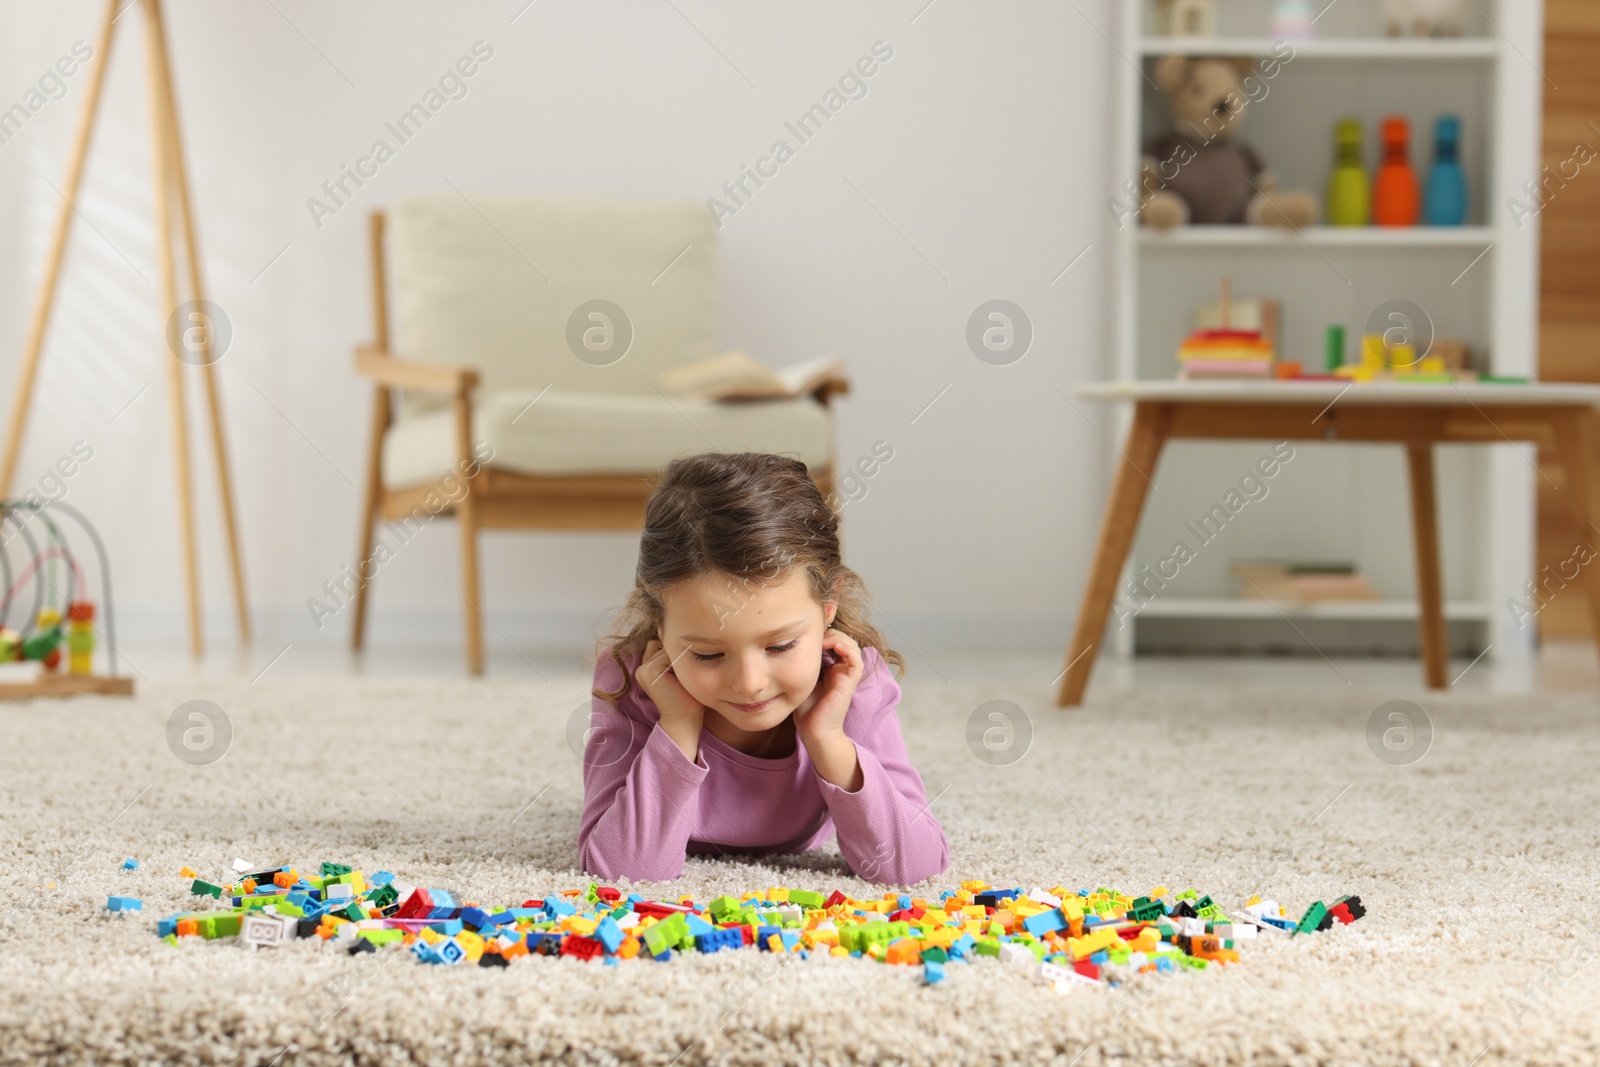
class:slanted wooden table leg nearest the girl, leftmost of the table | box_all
[1056,403,1173,707]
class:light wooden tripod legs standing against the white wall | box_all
[0,0,250,656]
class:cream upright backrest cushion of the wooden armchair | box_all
[386,192,717,421]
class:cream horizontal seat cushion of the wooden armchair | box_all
[382,389,830,490]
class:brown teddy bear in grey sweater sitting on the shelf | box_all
[1139,56,1322,229]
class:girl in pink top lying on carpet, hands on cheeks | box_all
[578,453,950,885]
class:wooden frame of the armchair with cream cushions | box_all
[350,211,850,675]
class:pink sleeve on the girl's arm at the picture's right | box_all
[816,648,950,885]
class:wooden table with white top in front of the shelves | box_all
[1056,381,1600,707]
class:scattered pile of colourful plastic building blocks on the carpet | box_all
[147,861,1366,992]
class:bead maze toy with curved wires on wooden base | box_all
[0,499,133,699]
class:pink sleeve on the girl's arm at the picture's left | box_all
[578,649,710,881]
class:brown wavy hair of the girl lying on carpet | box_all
[592,453,906,704]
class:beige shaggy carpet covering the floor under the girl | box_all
[0,677,1600,1067]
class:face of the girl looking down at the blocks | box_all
[661,568,838,733]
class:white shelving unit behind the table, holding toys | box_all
[1110,0,1542,656]
